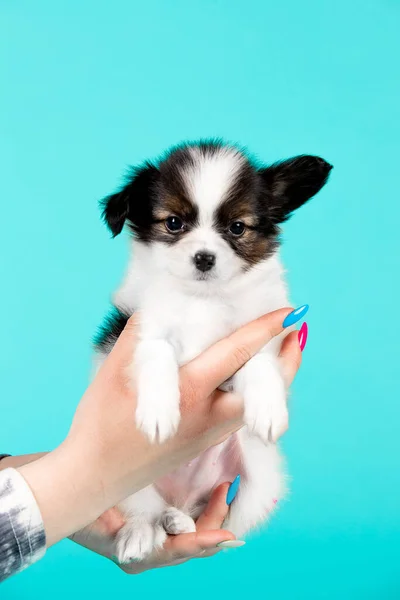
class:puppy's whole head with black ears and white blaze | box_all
[103,142,332,282]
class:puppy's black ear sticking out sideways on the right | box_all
[259,155,333,223]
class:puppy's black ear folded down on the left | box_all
[100,163,159,237]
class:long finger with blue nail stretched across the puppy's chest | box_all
[181,308,292,394]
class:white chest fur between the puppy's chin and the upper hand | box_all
[115,246,288,365]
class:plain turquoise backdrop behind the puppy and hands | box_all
[0,0,400,600]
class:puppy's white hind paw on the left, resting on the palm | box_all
[115,519,167,564]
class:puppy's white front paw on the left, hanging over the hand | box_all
[136,374,180,443]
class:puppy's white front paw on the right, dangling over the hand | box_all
[242,372,289,444]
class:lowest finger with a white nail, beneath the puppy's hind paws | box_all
[164,529,235,557]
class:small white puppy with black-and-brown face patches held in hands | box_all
[96,141,332,563]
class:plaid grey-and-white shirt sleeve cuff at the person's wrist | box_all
[0,469,46,582]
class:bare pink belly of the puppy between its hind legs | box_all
[156,434,243,514]
